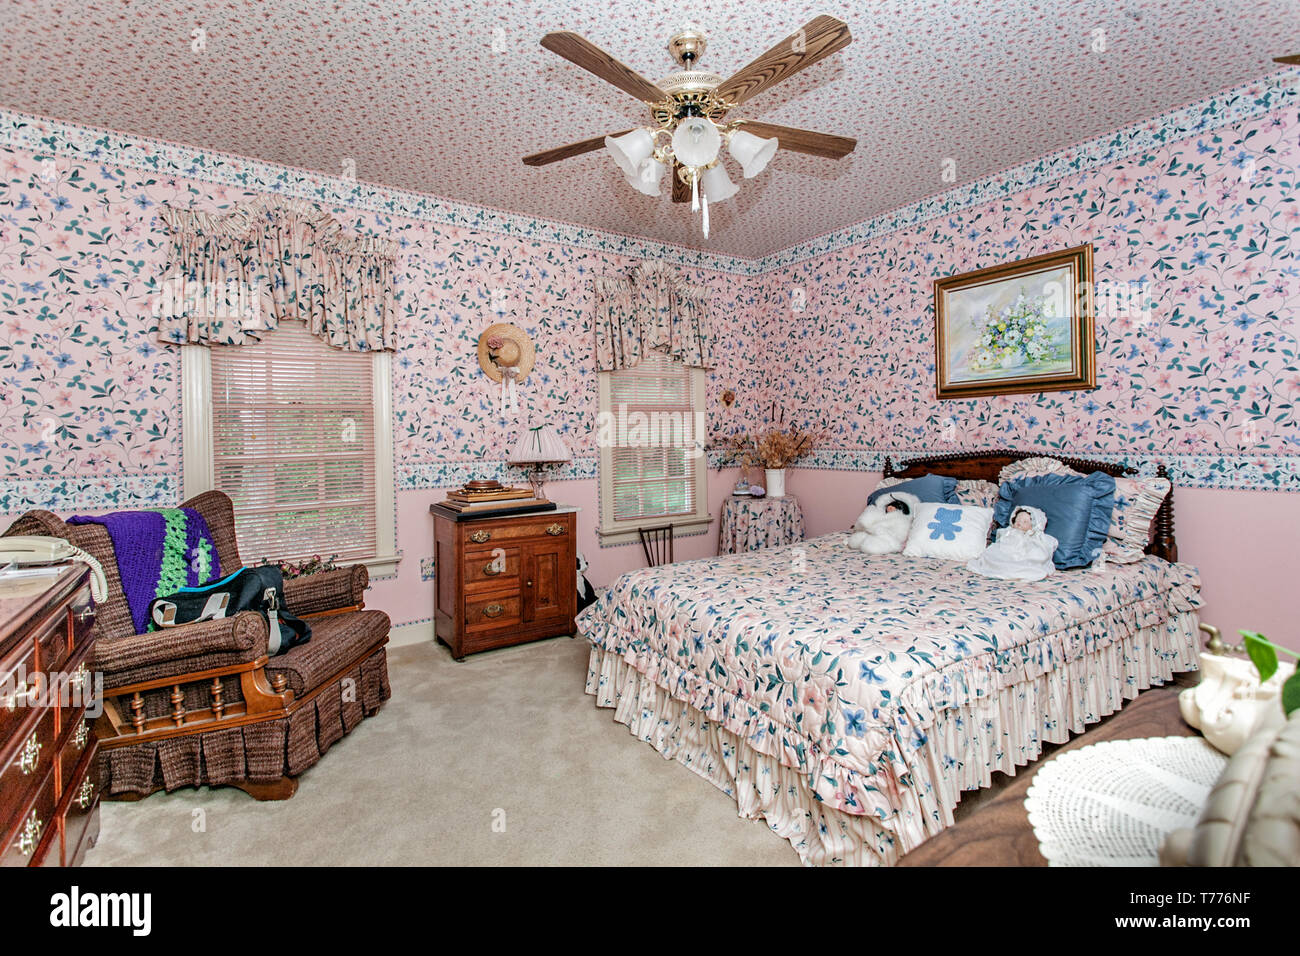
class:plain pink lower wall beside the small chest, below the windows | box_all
[365,468,736,626]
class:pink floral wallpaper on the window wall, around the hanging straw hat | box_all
[0,138,766,514]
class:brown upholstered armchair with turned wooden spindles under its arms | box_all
[5,492,390,800]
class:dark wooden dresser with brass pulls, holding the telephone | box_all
[0,564,99,866]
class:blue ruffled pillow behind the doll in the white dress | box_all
[993,471,1115,571]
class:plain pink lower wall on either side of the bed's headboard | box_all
[787,468,1300,649]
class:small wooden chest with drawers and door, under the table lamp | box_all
[429,506,577,661]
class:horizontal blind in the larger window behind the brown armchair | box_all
[212,321,377,564]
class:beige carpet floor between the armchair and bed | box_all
[86,637,798,866]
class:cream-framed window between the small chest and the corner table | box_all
[598,351,709,544]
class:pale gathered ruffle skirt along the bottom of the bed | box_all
[586,610,1199,866]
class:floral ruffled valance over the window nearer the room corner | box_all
[595,261,714,372]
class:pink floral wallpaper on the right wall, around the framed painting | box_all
[764,99,1300,490]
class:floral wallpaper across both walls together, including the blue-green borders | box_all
[0,70,1300,538]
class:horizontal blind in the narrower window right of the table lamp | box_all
[607,351,702,524]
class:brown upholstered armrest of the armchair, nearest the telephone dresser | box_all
[94,611,267,689]
